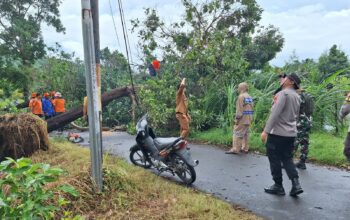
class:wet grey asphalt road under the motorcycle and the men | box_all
[76,132,350,220]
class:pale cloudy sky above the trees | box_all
[43,0,350,66]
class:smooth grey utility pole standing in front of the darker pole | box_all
[81,0,102,192]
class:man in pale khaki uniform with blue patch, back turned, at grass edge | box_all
[225,82,254,154]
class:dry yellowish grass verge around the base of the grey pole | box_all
[32,139,259,220]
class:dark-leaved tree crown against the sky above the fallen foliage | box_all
[133,0,284,73]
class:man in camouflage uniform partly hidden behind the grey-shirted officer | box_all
[294,89,312,170]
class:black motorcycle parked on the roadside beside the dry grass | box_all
[129,114,199,185]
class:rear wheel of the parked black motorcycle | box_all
[173,155,196,185]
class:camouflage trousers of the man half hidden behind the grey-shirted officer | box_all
[294,115,312,162]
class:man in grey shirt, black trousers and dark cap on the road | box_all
[261,73,303,196]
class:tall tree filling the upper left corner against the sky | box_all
[0,0,65,65]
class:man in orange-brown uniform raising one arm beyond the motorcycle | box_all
[176,78,191,139]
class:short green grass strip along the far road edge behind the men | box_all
[191,128,349,168]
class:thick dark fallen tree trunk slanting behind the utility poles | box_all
[47,86,132,132]
